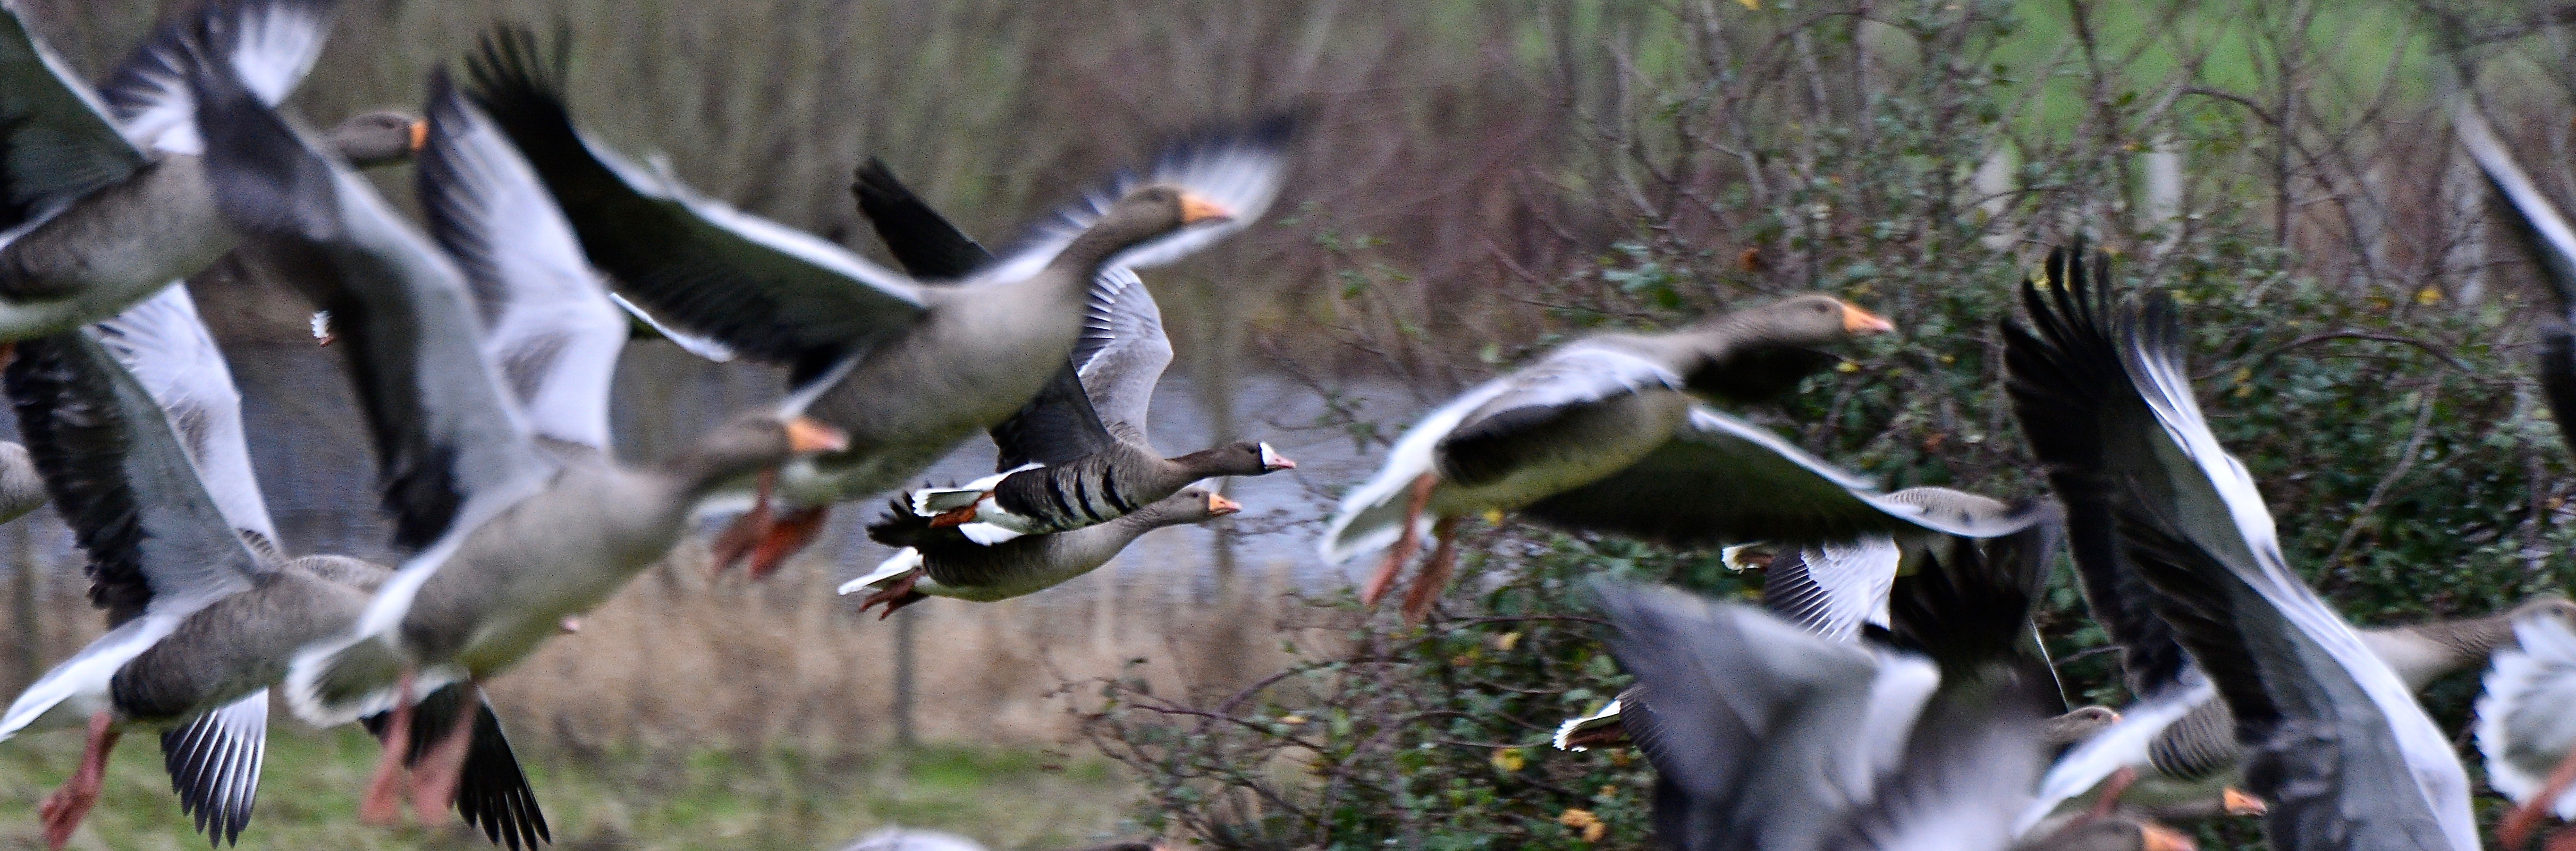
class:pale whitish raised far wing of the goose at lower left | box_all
[98,283,278,545]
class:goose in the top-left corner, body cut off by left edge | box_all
[0,0,420,342]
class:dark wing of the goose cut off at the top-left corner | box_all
[0,0,144,232]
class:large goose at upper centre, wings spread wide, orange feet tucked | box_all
[471,31,1286,576]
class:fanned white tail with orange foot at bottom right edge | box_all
[2478,612,2576,848]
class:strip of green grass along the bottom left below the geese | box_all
[0,728,1134,851]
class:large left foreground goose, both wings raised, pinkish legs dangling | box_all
[191,64,840,820]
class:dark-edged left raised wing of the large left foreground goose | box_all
[191,40,551,548]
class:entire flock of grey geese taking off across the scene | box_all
[0,0,2576,851]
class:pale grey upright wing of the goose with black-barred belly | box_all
[1071,267,1172,447]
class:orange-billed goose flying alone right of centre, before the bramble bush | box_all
[1322,296,1937,619]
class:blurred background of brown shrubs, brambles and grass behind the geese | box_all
[0,0,2576,848]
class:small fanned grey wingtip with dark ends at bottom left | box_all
[162,689,268,846]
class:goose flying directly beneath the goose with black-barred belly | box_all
[840,489,1244,617]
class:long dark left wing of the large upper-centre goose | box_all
[466,28,922,362]
